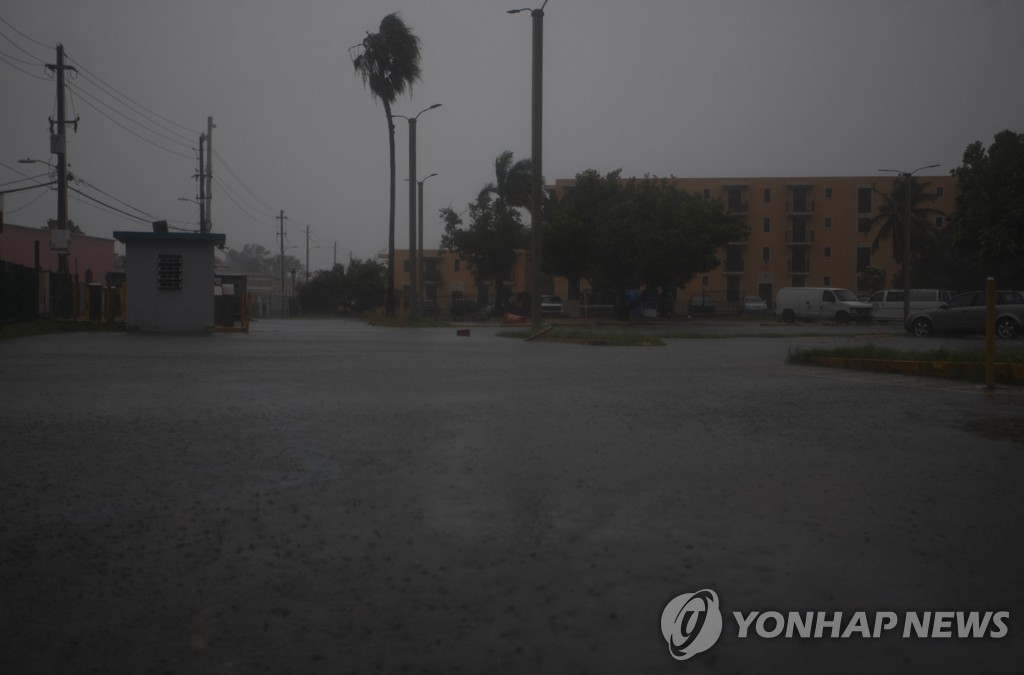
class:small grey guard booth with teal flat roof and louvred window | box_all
[114,231,225,333]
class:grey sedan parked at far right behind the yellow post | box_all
[903,291,1024,338]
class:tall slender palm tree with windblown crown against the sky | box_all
[349,13,421,317]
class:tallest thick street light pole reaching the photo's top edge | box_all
[508,0,548,333]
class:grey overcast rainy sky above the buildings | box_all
[0,0,1024,270]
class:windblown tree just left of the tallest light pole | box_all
[441,151,532,311]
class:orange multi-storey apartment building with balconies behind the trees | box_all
[384,174,956,314]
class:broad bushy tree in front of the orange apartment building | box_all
[545,170,750,315]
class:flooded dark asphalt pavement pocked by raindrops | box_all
[0,321,1024,675]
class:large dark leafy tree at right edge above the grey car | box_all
[949,130,1024,288]
